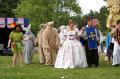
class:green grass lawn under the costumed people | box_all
[0,54,120,79]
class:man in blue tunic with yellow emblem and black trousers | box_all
[79,18,99,67]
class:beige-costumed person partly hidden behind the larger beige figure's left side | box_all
[36,24,46,64]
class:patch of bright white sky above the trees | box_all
[78,0,107,14]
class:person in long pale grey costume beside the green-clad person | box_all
[23,28,35,64]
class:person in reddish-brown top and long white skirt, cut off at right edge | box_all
[111,19,120,66]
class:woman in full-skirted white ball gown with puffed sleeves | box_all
[55,21,87,69]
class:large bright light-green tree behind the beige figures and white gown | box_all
[15,0,81,33]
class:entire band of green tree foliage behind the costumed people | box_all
[0,0,109,33]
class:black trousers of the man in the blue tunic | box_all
[85,41,99,67]
